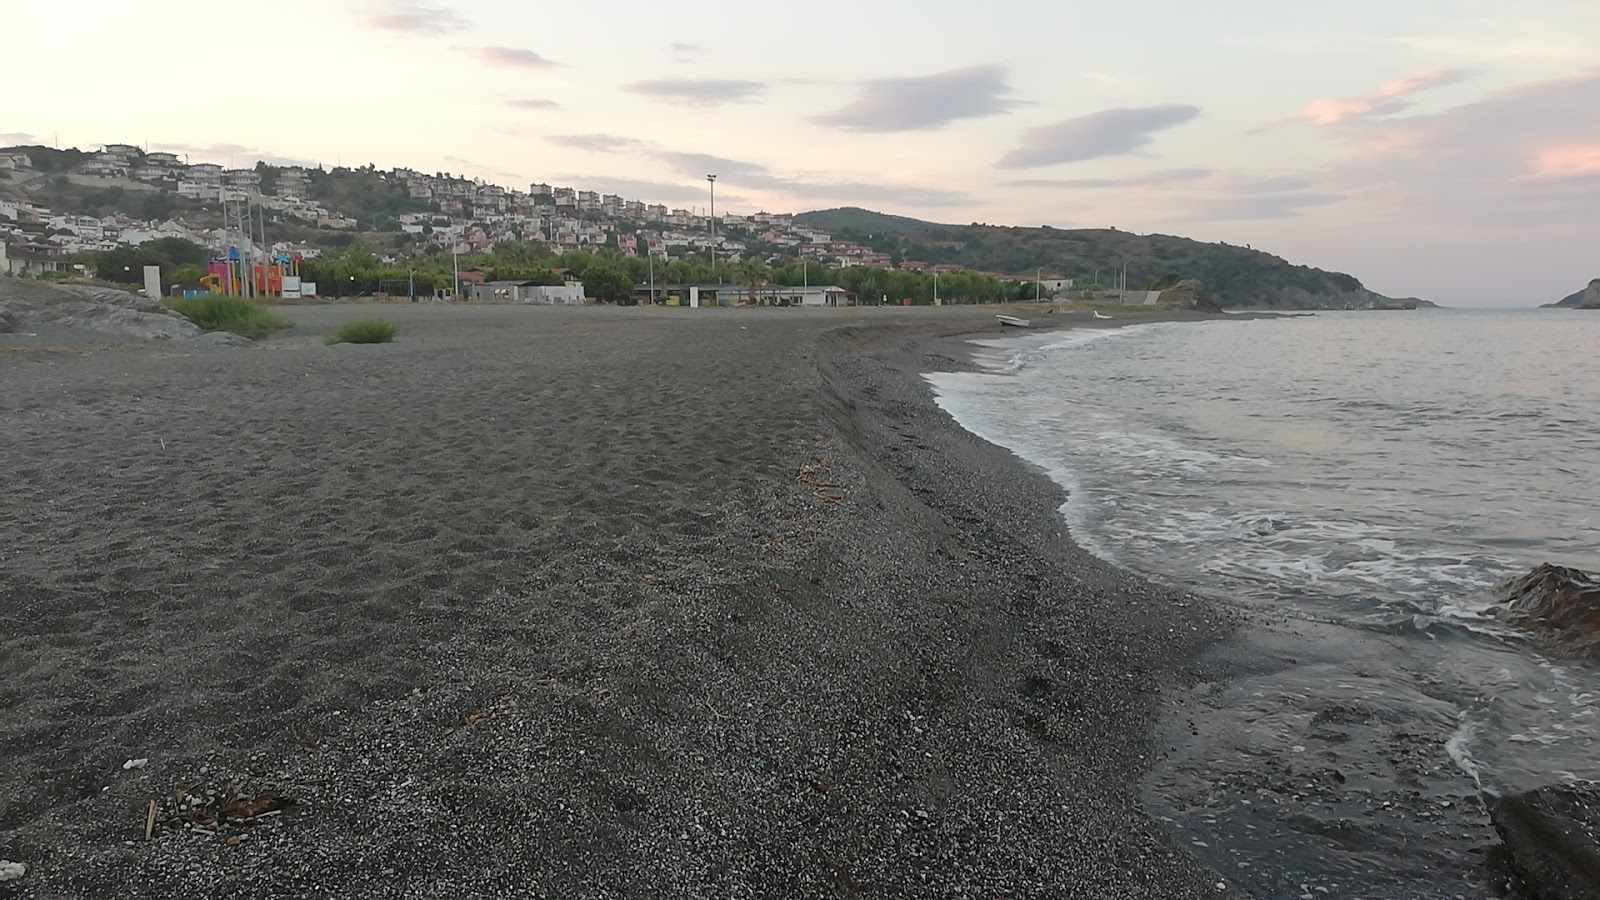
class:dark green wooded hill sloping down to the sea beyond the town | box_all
[795,207,1435,309]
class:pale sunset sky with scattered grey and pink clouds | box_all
[0,0,1600,306]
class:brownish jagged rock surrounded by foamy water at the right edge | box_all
[1494,562,1600,663]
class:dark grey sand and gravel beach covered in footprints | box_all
[0,306,1234,898]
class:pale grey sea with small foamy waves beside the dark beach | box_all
[928,309,1600,793]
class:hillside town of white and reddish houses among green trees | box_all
[0,144,1036,279]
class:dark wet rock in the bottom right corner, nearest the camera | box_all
[1488,785,1600,900]
